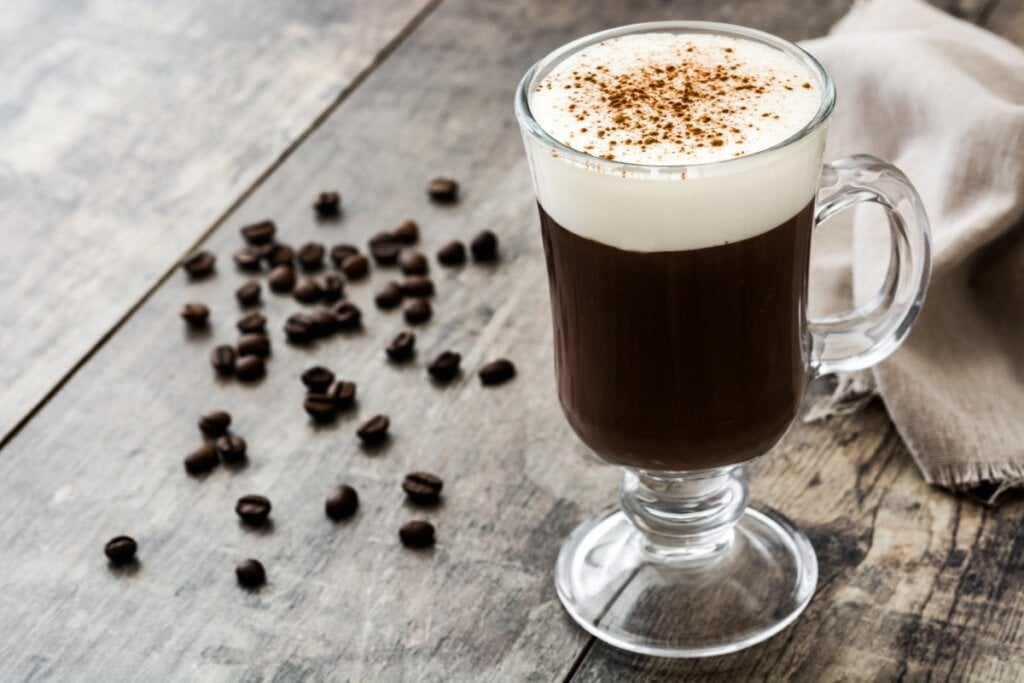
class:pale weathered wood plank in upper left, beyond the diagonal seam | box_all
[0,0,430,442]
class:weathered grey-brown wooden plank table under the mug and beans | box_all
[0,0,1024,681]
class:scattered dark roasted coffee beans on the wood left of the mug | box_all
[104,178,515,588]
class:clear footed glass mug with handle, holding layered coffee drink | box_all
[515,22,931,656]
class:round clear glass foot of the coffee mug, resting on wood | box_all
[555,508,818,657]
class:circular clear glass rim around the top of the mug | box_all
[515,20,836,174]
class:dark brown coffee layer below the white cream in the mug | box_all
[541,203,814,471]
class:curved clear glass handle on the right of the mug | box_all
[807,155,932,376]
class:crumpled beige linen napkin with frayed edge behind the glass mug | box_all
[805,0,1024,503]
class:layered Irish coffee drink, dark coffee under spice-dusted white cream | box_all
[526,33,824,471]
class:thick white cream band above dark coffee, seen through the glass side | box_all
[525,34,825,252]
